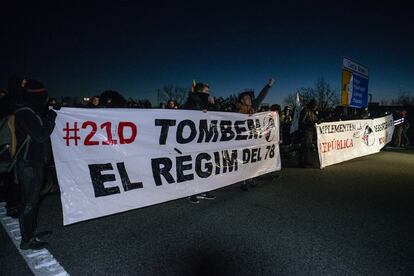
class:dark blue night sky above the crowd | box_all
[0,1,414,103]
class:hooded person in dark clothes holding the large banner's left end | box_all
[15,80,56,250]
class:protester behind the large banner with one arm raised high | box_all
[236,78,275,191]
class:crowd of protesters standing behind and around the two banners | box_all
[0,75,409,249]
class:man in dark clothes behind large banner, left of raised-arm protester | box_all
[183,82,216,203]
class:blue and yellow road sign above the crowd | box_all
[341,57,368,108]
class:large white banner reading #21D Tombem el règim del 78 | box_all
[51,108,281,225]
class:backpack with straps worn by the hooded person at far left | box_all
[0,107,35,173]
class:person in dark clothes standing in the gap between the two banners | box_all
[299,99,318,168]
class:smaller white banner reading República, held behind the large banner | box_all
[316,115,394,168]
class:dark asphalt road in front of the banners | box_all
[0,150,414,275]
